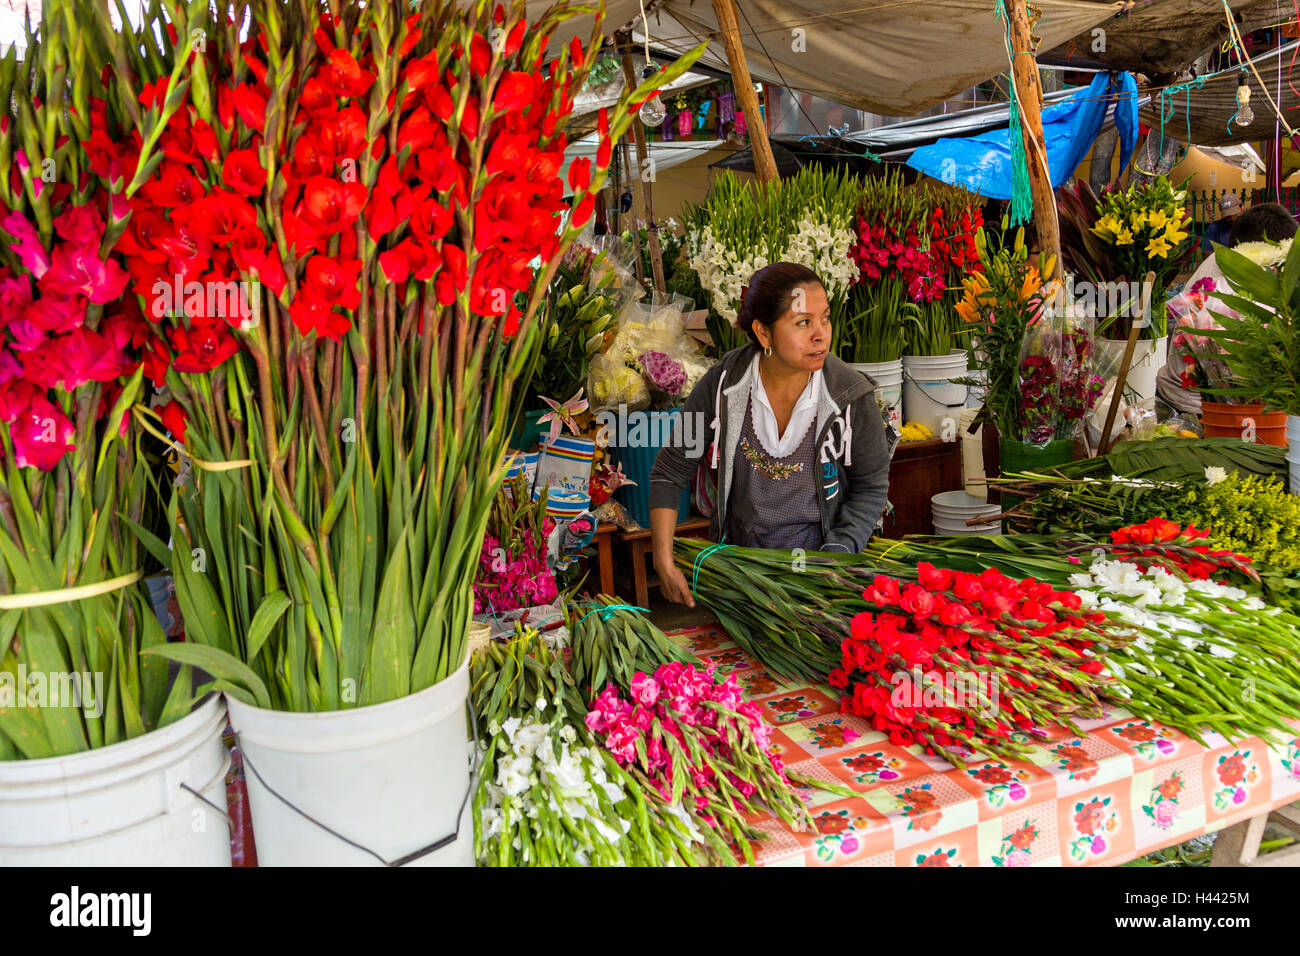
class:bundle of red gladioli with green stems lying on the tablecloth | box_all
[676,540,1125,762]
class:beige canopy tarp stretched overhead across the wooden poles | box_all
[529,0,1123,116]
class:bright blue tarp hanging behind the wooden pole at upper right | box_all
[907,73,1138,199]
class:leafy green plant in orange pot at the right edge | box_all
[1188,239,1300,465]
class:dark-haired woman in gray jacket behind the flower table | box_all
[650,263,898,607]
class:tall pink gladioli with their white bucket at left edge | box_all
[0,1,230,866]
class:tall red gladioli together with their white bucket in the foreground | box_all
[104,0,699,865]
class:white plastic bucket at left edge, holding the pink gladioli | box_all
[0,695,230,866]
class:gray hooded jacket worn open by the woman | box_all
[650,345,898,553]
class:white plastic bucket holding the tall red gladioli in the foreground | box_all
[229,659,475,866]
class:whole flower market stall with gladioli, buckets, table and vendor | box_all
[0,0,1300,868]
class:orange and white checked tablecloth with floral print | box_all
[673,626,1300,866]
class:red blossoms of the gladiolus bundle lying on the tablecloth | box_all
[829,563,1117,762]
